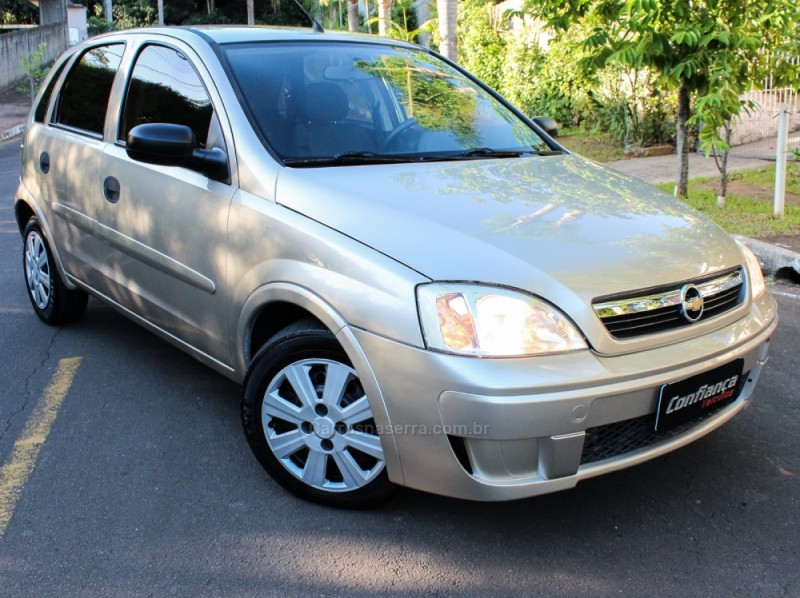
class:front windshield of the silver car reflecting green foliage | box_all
[224,42,558,166]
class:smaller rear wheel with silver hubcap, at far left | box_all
[22,217,89,325]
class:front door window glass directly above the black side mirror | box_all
[120,46,214,147]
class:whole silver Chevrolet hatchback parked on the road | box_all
[16,27,778,506]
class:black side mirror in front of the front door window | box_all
[125,123,230,181]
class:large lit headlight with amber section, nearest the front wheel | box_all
[417,283,587,357]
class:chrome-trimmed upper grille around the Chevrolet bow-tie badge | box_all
[593,268,745,339]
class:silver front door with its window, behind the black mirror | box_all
[97,43,235,365]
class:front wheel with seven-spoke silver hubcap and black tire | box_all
[241,320,395,508]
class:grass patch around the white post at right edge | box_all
[658,163,800,237]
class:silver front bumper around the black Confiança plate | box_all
[352,294,778,501]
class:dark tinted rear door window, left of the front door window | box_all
[56,44,125,135]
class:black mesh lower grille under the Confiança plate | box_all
[581,396,736,465]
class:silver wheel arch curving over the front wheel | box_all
[234,282,404,485]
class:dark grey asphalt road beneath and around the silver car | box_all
[0,142,800,597]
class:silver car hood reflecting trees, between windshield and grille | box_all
[276,155,742,311]
